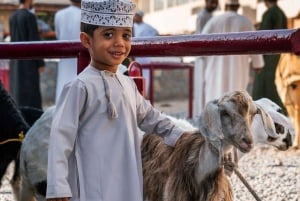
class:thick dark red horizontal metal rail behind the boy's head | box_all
[0,29,300,118]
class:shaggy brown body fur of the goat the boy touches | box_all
[142,133,233,201]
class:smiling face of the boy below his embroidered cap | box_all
[80,26,132,72]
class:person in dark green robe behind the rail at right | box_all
[252,0,287,112]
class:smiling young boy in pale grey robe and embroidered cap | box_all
[47,0,190,201]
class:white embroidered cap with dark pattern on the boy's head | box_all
[81,0,135,27]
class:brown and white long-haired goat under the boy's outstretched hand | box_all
[142,91,276,201]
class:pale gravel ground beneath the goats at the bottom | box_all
[0,146,300,201]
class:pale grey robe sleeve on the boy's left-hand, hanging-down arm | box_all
[47,82,86,198]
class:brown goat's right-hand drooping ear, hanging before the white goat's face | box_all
[256,104,279,139]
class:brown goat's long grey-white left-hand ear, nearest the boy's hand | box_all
[199,100,224,141]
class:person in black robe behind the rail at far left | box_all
[9,0,45,109]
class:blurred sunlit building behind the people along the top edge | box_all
[0,0,300,35]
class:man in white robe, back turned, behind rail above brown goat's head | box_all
[202,0,264,103]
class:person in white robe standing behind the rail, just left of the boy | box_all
[54,0,81,101]
